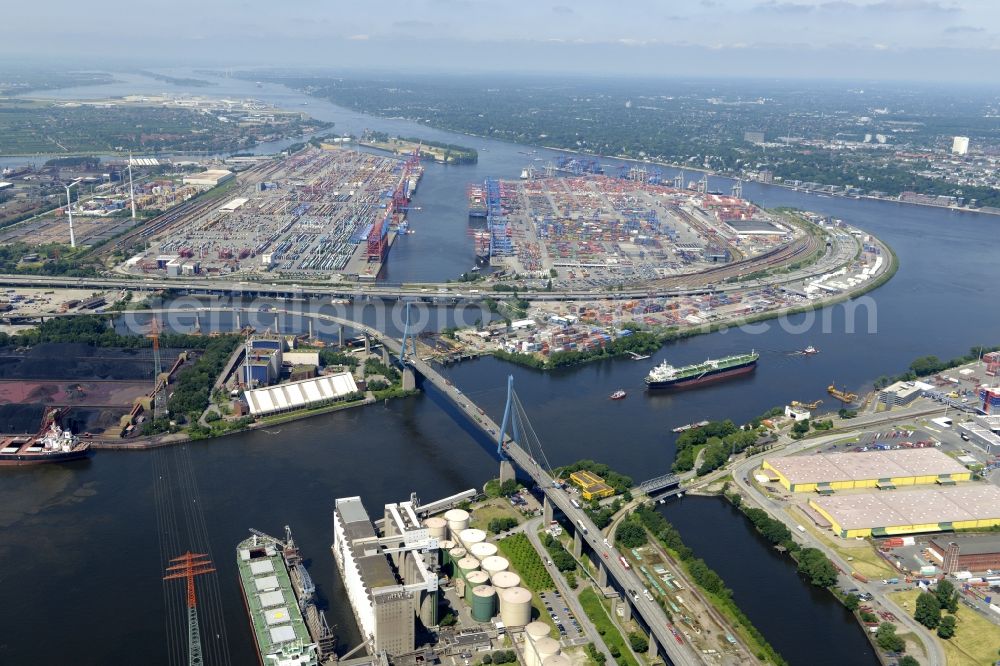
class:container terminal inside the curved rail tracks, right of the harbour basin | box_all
[468,175,804,286]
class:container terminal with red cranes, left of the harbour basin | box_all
[119,147,422,280]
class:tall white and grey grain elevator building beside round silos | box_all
[333,497,439,657]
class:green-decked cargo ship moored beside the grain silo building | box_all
[236,526,336,666]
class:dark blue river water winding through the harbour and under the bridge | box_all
[0,72,1000,664]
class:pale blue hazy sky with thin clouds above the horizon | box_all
[0,0,1000,83]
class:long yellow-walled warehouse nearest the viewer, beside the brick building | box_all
[809,484,1000,539]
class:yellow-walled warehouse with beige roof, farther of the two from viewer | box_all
[763,448,972,494]
